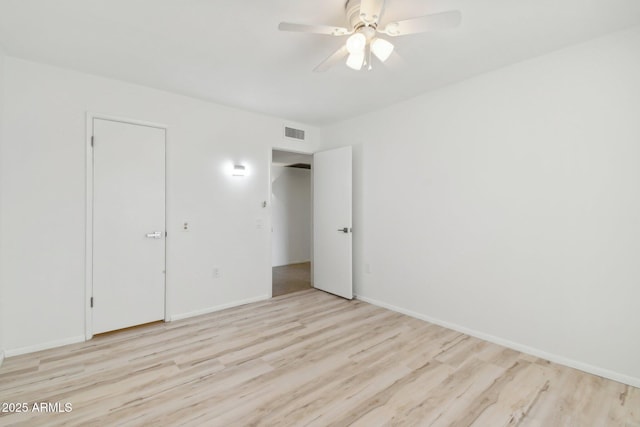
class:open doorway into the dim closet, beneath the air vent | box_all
[271,150,313,297]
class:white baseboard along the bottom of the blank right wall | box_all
[354,295,640,388]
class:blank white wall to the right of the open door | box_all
[323,27,640,386]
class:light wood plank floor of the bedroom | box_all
[0,290,640,427]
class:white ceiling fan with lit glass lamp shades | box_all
[278,0,461,71]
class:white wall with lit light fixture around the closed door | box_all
[0,57,317,354]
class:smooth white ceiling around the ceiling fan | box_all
[0,0,640,125]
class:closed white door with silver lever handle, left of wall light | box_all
[92,119,165,334]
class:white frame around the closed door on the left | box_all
[84,112,170,341]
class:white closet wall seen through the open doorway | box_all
[271,165,311,267]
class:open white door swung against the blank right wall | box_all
[313,147,353,299]
